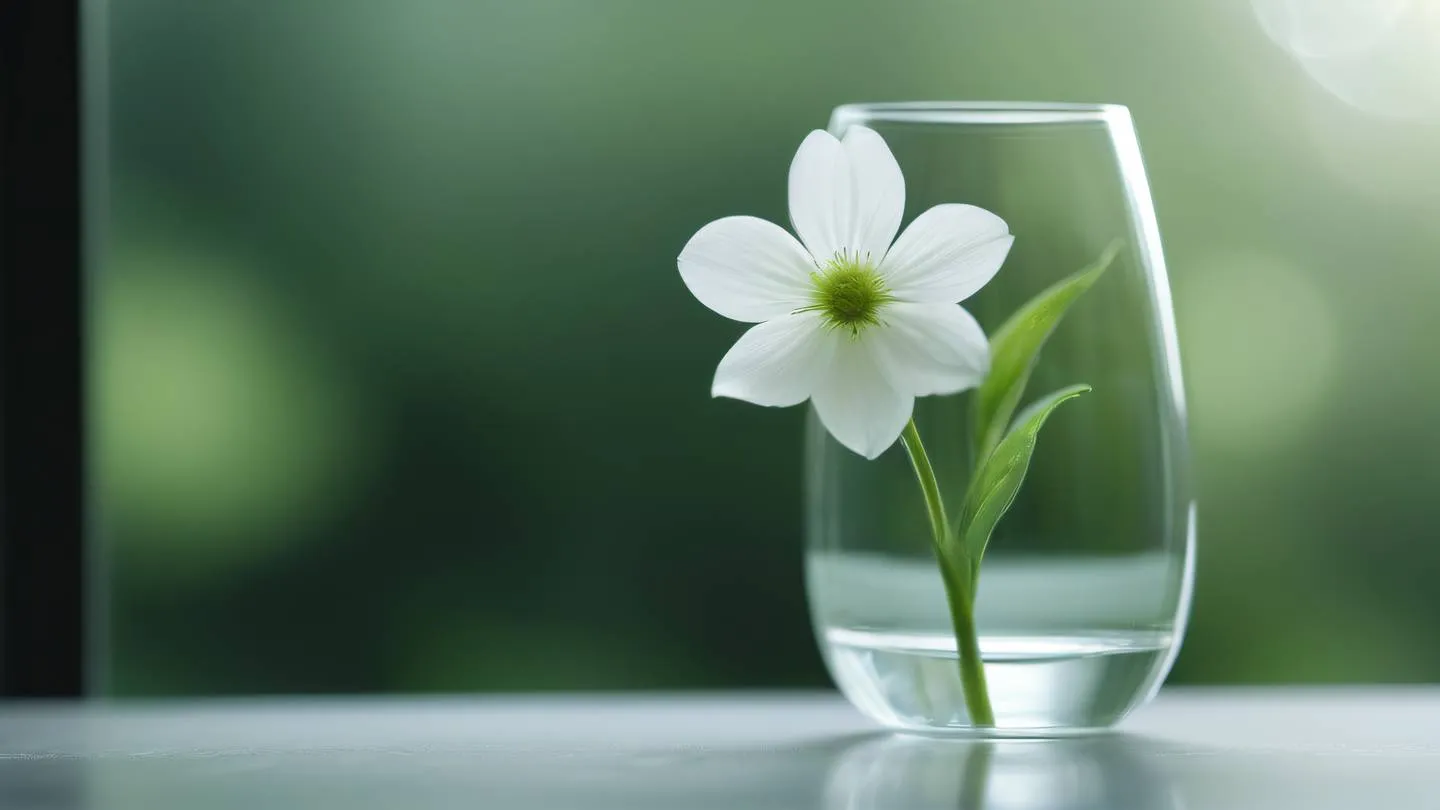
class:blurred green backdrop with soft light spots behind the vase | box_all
[89,0,1440,695]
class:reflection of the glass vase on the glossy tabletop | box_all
[824,735,1179,810]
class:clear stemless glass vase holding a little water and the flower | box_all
[805,102,1195,736]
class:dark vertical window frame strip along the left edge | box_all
[0,0,86,698]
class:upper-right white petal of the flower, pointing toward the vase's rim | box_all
[880,203,1015,304]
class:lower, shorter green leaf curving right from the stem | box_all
[949,385,1090,567]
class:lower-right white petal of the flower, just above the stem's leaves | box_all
[865,301,989,396]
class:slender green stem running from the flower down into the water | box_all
[900,419,995,726]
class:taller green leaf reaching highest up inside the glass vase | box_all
[975,239,1122,463]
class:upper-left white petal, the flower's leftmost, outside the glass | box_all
[675,216,815,323]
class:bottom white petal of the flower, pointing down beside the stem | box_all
[811,330,914,458]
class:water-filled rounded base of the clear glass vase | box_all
[822,627,1174,736]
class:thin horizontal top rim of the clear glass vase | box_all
[831,101,1130,125]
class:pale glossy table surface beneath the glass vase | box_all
[0,687,1440,810]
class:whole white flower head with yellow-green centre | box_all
[678,127,1014,458]
